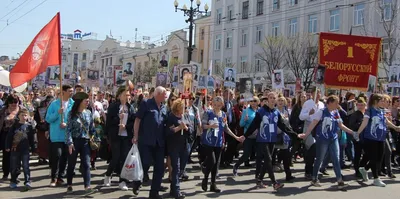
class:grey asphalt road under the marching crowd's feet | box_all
[0,155,400,199]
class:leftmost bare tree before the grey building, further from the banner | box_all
[256,37,286,82]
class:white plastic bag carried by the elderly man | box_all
[121,144,143,181]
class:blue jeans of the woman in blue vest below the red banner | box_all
[313,138,342,182]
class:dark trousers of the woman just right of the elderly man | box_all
[169,144,189,196]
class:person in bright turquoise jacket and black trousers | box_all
[45,85,74,187]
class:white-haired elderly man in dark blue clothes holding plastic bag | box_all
[132,86,167,199]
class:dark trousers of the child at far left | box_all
[10,151,31,184]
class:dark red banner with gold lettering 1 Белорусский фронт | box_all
[319,33,382,91]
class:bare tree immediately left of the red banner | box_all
[285,34,318,89]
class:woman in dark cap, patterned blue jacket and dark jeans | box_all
[65,92,97,193]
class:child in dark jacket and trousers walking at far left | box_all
[5,108,35,191]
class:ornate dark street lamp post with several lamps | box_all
[174,0,209,63]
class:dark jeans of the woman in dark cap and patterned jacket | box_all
[67,138,90,188]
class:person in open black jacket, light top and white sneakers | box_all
[104,86,135,191]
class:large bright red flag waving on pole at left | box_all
[10,13,61,88]
